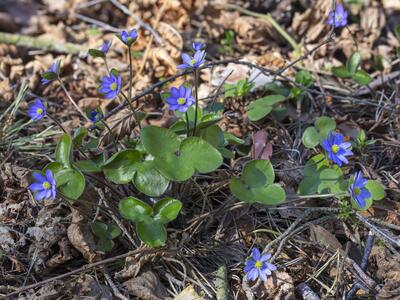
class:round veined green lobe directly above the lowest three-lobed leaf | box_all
[133,160,169,197]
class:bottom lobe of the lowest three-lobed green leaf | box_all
[136,222,167,248]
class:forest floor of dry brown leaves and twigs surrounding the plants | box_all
[0,0,400,300]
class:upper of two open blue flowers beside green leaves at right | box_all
[322,131,353,167]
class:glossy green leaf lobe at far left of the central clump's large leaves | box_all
[102,149,142,184]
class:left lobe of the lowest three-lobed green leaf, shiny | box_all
[118,197,153,223]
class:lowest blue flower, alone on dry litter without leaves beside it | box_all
[244,248,276,281]
